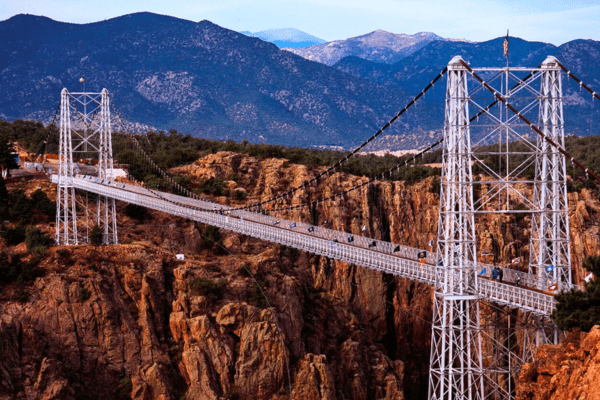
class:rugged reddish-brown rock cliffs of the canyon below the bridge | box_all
[0,152,600,400]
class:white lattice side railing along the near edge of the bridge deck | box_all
[53,176,554,315]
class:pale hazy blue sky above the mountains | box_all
[0,0,600,44]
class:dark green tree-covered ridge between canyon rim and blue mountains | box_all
[0,120,600,190]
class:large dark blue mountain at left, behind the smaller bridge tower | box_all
[0,13,412,147]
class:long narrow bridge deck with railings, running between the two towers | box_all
[56,175,555,315]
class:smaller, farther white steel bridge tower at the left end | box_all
[55,88,118,245]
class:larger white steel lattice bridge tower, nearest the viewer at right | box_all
[429,56,572,400]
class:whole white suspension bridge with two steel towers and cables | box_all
[43,57,600,400]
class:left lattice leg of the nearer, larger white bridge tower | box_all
[429,57,483,400]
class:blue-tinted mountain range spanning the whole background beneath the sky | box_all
[0,13,600,148]
